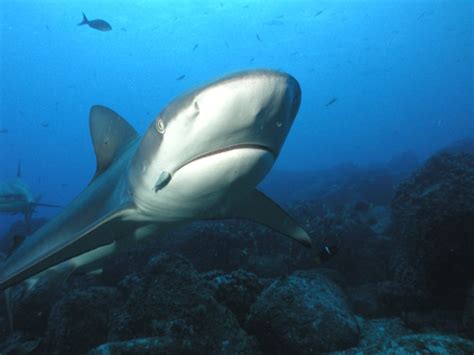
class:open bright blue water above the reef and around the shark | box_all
[0,0,474,233]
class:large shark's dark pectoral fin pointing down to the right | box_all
[226,190,311,247]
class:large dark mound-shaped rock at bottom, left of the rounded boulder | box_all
[109,254,258,354]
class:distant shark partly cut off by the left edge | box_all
[0,164,60,232]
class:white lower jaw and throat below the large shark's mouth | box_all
[134,148,274,222]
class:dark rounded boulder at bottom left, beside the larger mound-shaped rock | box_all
[42,287,121,354]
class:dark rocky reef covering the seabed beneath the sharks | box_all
[0,147,474,354]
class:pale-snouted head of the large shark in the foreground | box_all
[129,70,301,221]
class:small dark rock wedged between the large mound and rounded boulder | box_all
[207,270,263,324]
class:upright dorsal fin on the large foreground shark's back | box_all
[89,105,138,180]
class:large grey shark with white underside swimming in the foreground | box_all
[0,70,311,289]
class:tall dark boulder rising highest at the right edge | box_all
[392,153,474,309]
